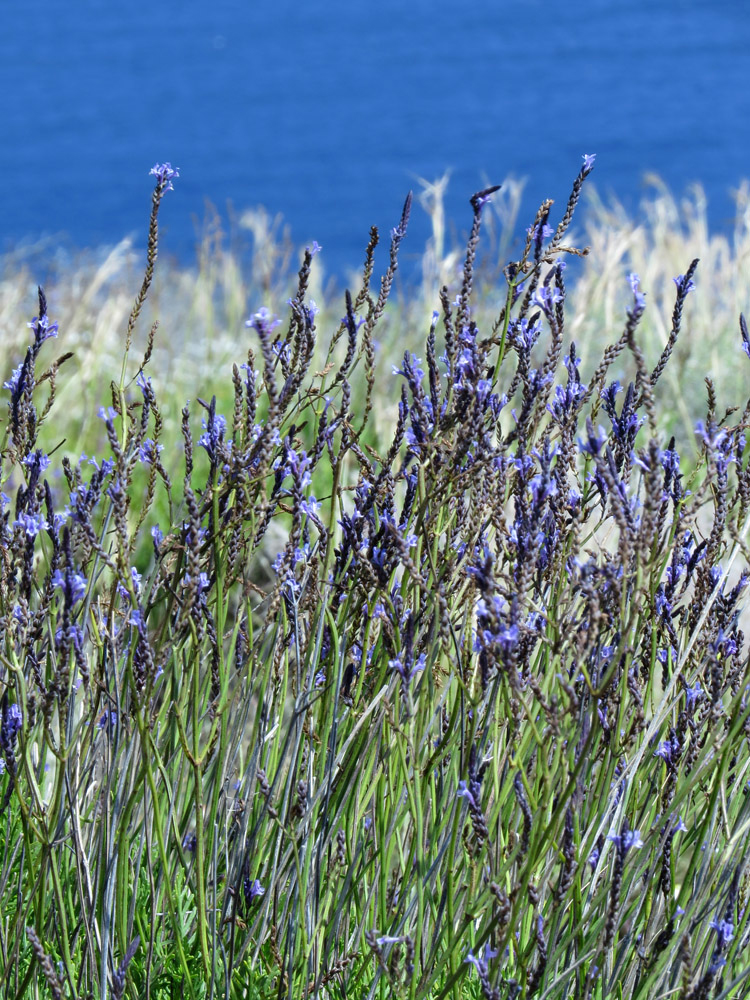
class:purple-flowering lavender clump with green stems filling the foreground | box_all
[0,156,750,1000]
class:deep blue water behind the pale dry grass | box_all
[0,0,750,284]
